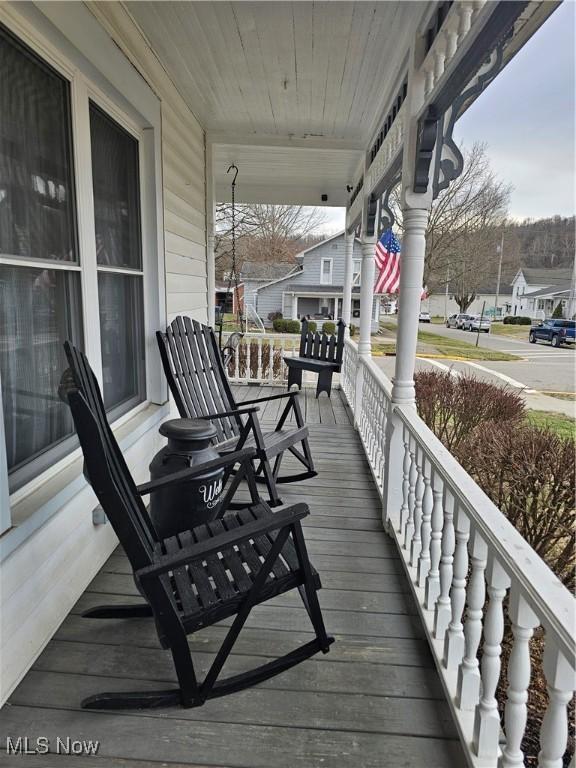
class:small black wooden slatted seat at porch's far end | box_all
[284,320,346,397]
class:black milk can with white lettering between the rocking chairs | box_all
[150,419,224,539]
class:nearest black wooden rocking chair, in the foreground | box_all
[60,342,333,709]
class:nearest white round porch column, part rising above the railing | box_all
[392,207,429,405]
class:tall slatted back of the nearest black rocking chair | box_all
[60,341,158,568]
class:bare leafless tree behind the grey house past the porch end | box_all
[215,203,326,272]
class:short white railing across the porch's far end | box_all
[223,333,300,385]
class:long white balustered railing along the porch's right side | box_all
[342,339,576,768]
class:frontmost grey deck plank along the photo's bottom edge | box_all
[3,706,464,768]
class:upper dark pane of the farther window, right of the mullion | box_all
[90,103,142,269]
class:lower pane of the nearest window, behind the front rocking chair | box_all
[0,265,82,480]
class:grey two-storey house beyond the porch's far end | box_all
[251,232,380,331]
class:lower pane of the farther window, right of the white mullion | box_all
[98,272,145,411]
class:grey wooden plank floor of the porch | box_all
[0,387,465,768]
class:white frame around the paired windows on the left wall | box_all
[0,4,167,510]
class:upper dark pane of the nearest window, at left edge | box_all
[0,26,77,261]
